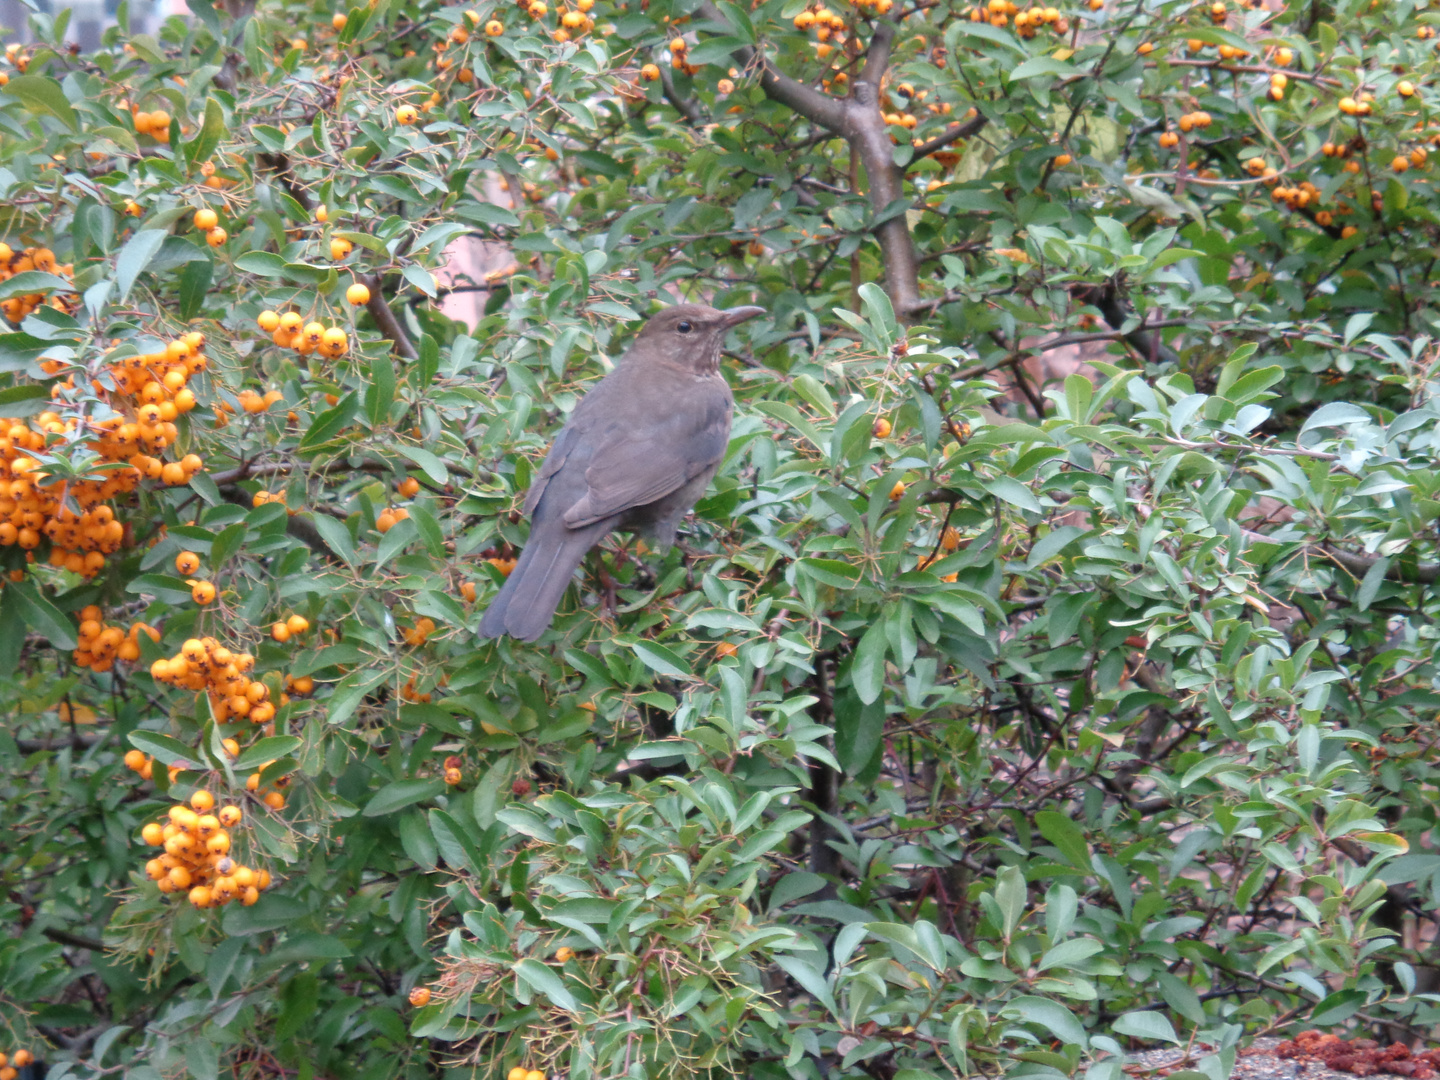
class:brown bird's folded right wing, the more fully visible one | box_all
[564,389,730,528]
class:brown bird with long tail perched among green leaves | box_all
[480,304,765,641]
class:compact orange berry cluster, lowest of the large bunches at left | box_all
[141,789,271,907]
